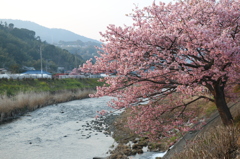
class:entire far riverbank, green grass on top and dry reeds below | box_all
[0,79,101,121]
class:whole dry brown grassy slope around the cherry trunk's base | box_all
[167,102,240,159]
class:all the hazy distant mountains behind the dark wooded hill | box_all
[0,19,101,62]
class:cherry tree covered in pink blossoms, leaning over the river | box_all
[79,0,240,139]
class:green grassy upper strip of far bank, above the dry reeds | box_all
[0,78,101,97]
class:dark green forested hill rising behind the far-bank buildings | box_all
[0,23,83,73]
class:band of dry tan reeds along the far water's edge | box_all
[0,90,94,121]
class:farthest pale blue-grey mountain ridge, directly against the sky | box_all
[0,19,100,44]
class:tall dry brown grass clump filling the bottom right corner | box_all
[173,126,240,159]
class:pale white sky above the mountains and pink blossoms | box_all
[0,0,171,40]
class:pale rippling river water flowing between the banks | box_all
[0,97,165,159]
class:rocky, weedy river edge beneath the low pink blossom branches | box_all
[85,109,166,159]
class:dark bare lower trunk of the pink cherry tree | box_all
[214,84,233,125]
